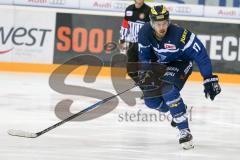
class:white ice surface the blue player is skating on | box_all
[0,72,240,160]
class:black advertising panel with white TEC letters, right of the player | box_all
[174,21,240,74]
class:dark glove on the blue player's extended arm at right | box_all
[203,75,221,100]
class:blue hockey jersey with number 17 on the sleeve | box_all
[138,23,212,78]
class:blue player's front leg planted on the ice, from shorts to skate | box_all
[162,62,193,149]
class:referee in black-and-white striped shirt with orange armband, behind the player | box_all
[119,0,150,84]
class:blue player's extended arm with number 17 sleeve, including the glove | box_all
[182,32,221,100]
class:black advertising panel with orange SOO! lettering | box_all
[54,13,121,65]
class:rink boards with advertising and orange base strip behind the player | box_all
[0,6,240,83]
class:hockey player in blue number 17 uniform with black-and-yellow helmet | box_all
[138,5,221,149]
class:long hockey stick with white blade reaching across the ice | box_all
[8,84,138,138]
